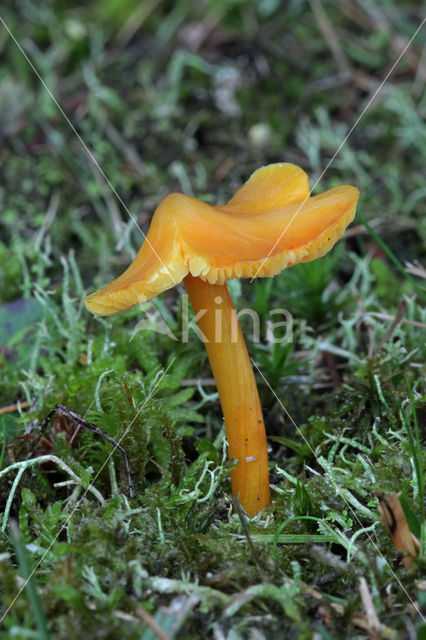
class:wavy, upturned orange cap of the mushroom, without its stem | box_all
[85,163,359,316]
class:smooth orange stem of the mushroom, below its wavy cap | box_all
[184,274,269,516]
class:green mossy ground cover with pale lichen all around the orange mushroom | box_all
[0,1,426,640]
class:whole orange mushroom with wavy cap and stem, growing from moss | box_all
[85,163,359,516]
